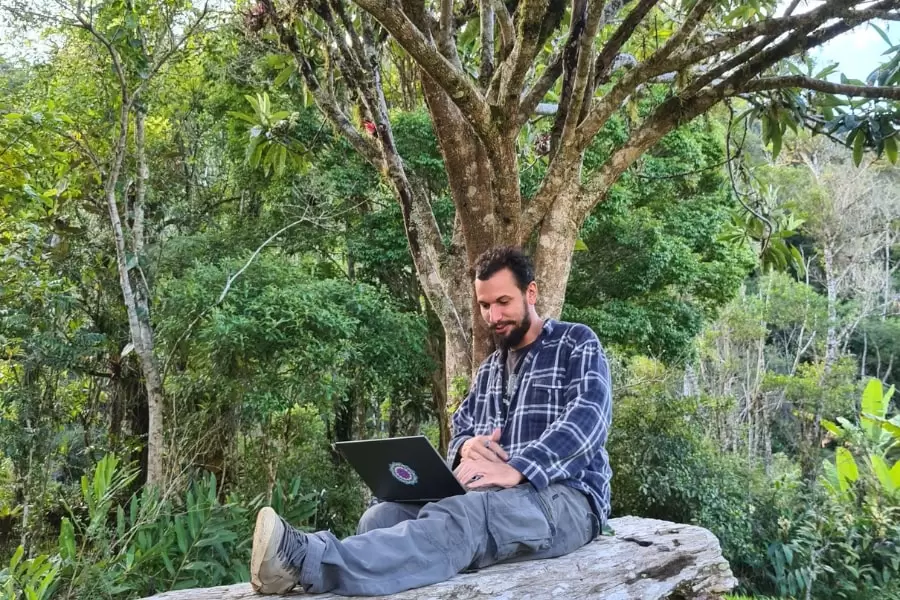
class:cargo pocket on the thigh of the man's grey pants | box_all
[487,484,553,562]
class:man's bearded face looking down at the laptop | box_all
[475,269,537,348]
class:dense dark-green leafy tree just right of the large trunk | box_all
[563,115,756,363]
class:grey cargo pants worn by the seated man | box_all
[300,483,600,596]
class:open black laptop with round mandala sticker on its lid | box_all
[334,435,466,502]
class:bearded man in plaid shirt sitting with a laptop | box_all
[250,247,612,595]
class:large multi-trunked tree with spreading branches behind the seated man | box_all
[246,0,900,400]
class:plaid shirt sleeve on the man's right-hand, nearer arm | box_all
[508,328,612,489]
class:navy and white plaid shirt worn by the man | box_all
[448,319,612,522]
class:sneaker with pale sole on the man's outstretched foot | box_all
[250,506,306,594]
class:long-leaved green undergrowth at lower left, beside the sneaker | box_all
[7,455,317,600]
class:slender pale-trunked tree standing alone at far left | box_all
[2,0,207,485]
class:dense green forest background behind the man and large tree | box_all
[0,3,900,600]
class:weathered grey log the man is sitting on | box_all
[142,517,737,600]
